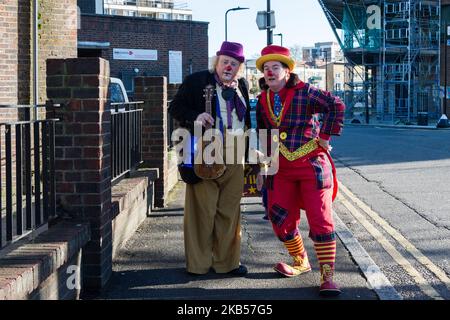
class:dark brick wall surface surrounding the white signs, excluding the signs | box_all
[78,14,208,77]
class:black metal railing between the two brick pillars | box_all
[111,101,143,184]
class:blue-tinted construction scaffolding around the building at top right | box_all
[319,0,441,124]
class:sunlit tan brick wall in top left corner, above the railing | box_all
[0,0,77,105]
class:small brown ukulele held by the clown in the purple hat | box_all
[194,85,227,180]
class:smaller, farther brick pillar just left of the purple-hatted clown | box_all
[134,77,169,207]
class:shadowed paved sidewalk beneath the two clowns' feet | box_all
[97,183,377,300]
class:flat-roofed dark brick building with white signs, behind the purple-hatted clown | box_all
[78,14,208,92]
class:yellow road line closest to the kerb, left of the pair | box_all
[339,194,444,300]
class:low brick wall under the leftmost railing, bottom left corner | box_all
[0,221,90,300]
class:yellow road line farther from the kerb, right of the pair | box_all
[339,184,450,290]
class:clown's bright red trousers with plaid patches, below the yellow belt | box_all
[267,153,335,242]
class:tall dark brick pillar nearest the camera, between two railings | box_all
[47,58,112,291]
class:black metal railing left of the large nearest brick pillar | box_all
[0,103,60,249]
